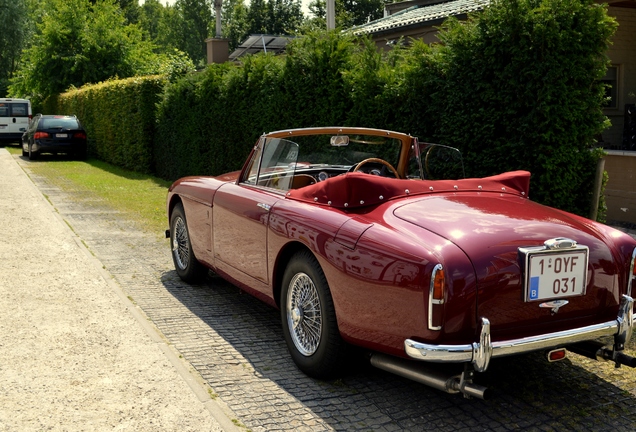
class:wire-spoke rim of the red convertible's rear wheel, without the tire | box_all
[287,273,322,356]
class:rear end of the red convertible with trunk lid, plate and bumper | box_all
[376,191,636,396]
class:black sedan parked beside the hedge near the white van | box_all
[22,114,87,160]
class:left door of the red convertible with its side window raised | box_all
[212,139,298,295]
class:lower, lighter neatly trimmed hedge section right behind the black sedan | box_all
[52,76,166,173]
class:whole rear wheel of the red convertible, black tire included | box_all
[280,251,347,379]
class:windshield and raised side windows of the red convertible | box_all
[241,131,464,191]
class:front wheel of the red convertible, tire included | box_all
[170,203,207,282]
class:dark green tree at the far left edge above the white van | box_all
[0,0,28,96]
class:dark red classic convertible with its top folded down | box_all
[166,127,636,398]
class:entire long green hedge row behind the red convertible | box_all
[51,0,616,215]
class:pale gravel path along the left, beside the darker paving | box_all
[0,149,231,431]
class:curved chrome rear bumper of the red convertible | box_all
[404,295,634,372]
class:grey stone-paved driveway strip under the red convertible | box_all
[4,148,636,431]
